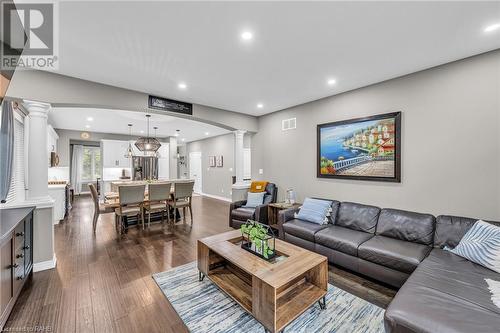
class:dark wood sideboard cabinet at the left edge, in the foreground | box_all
[0,207,34,331]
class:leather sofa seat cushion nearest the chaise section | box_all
[358,236,432,273]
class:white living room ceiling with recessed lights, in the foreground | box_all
[47,1,500,115]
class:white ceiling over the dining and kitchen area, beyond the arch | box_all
[49,107,230,143]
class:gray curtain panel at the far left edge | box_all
[0,100,14,203]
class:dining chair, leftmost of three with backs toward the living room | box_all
[115,184,146,234]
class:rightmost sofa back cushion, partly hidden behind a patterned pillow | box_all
[434,215,500,249]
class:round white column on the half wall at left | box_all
[23,100,50,200]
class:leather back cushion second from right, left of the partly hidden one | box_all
[376,208,435,245]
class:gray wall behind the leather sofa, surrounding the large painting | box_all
[252,50,500,220]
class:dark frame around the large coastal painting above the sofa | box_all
[316,111,402,183]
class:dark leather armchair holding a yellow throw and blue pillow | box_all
[229,183,278,229]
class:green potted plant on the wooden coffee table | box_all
[240,220,275,260]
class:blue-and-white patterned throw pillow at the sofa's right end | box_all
[444,220,500,273]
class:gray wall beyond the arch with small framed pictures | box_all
[186,133,235,199]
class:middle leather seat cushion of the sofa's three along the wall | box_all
[314,225,373,256]
